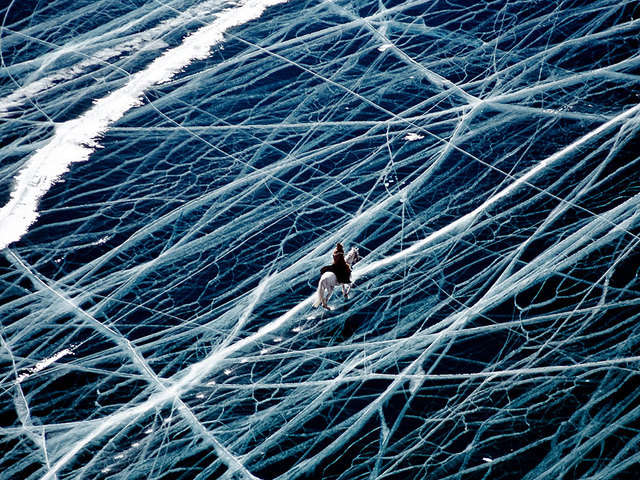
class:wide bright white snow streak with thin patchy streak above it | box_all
[0,0,284,253]
